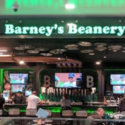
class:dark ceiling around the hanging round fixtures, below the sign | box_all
[0,38,125,62]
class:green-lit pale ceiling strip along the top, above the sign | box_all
[0,0,125,16]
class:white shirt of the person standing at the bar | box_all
[27,95,41,109]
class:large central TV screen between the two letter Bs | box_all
[55,73,83,88]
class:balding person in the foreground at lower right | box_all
[85,108,104,125]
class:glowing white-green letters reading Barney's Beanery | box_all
[5,23,125,36]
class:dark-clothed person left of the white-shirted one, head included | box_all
[13,91,26,104]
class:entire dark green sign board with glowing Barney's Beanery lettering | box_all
[0,17,125,38]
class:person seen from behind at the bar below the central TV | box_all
[60,94,71,108]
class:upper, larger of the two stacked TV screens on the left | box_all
[9,73,28,84]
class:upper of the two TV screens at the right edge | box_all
[110,74,125,85]
